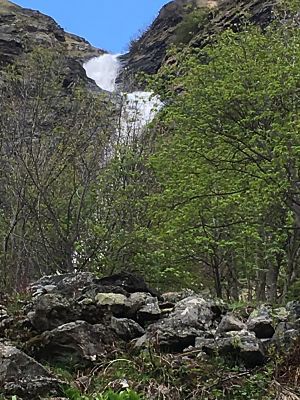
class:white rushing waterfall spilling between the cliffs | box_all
[84,54,162,138]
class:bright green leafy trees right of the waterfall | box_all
[146,10,300,301]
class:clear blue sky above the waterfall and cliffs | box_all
[12,0,170,53]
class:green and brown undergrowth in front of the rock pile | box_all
[55,348,276,400]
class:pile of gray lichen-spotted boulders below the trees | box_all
[0,272,300,399]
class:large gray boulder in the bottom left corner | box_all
[0,343,62,400]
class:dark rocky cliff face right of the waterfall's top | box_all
[118,0,276,89]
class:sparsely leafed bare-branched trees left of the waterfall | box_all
[0,49,112,287]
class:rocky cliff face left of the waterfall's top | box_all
[0,0,104,87]
